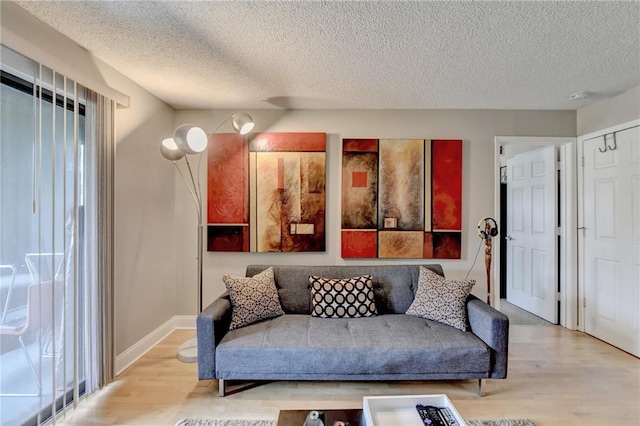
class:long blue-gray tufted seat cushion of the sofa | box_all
[216,314,491,380]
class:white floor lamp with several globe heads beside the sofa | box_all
[160,113,254,362]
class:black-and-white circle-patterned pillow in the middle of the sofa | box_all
[309,275,378,318]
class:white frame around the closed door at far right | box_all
[574,119,640,332]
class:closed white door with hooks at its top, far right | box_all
[578,127,640,356]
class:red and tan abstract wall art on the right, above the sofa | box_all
[342,139,462,259]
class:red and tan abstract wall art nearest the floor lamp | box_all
[207,133,326,252]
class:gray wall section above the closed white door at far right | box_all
[577,86,640,136]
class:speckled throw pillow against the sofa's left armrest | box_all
[222,268,284,330]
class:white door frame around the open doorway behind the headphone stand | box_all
[491,136,579,330]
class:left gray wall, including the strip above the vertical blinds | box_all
[0,2,178,355]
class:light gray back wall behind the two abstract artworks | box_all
[175,110,576,314]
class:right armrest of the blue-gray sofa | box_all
[467,295,509,379]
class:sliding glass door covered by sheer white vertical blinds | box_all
[0,46,115,425]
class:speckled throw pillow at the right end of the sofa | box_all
[406,266,476,331]
